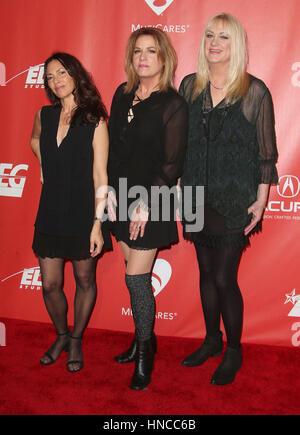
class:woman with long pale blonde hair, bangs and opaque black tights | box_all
[180,14,277,385]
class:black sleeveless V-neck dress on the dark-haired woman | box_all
[32,105,112,260]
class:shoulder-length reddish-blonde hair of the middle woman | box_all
[124,27,177,93]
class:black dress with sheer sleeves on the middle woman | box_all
[108,83,188,249]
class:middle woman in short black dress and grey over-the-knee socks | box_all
[108,28,187,390]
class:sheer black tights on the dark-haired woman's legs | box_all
[39,258,97,337]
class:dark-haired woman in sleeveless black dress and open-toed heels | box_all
[31,53,110,373]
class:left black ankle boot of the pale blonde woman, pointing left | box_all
[182,331,223,367]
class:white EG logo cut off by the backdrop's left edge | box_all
[0,163,28,198]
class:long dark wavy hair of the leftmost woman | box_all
[44,52,108,125]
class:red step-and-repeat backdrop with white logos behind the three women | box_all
[0,0,300,346]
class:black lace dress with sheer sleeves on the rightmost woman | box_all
[179,74,278,247]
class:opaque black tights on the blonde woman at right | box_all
[195,243,243,348]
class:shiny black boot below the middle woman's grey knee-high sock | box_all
[130,339,154,390]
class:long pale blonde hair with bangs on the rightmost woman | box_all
[193,13,249,104]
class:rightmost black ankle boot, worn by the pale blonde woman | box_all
[211,346,243,385]
